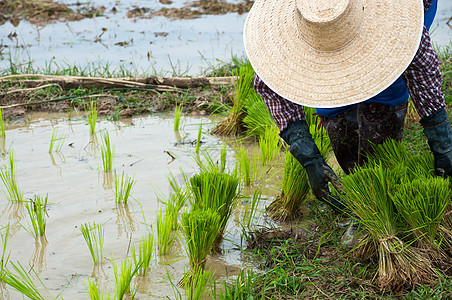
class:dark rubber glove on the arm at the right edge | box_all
[420,107,452,177]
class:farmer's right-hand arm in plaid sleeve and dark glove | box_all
[403,21,452,176]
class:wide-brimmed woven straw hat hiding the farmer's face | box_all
[244,0,424,108]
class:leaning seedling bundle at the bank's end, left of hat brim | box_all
[214,61,254,135]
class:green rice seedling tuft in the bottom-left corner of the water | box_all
[0,262,49,300]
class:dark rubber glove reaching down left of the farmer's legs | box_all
[280,120,345,212]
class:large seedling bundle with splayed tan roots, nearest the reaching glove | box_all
[342,165,437,291]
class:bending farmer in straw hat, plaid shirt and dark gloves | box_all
[244,0,452,230]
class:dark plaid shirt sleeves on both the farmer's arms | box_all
[254,0,446,131]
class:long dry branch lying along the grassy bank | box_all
[0,74,233,91]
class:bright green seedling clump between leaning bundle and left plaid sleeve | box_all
[243,91,275,137]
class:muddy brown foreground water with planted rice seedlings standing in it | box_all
[0,114,277,299]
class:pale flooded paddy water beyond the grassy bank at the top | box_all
[0,0,452,75]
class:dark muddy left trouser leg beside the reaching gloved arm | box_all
[323,108,359,174]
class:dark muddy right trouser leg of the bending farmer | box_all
[358,102,408,166]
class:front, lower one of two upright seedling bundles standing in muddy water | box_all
[181,209,221,280]
